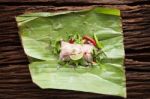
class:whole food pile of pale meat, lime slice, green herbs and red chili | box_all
[50,34,105,66]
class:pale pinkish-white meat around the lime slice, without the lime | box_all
[59,41,94,62]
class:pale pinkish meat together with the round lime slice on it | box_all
[59,34,95,63]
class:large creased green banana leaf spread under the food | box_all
[16,7,126,97]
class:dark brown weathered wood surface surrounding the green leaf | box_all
[0,0,150,99]
